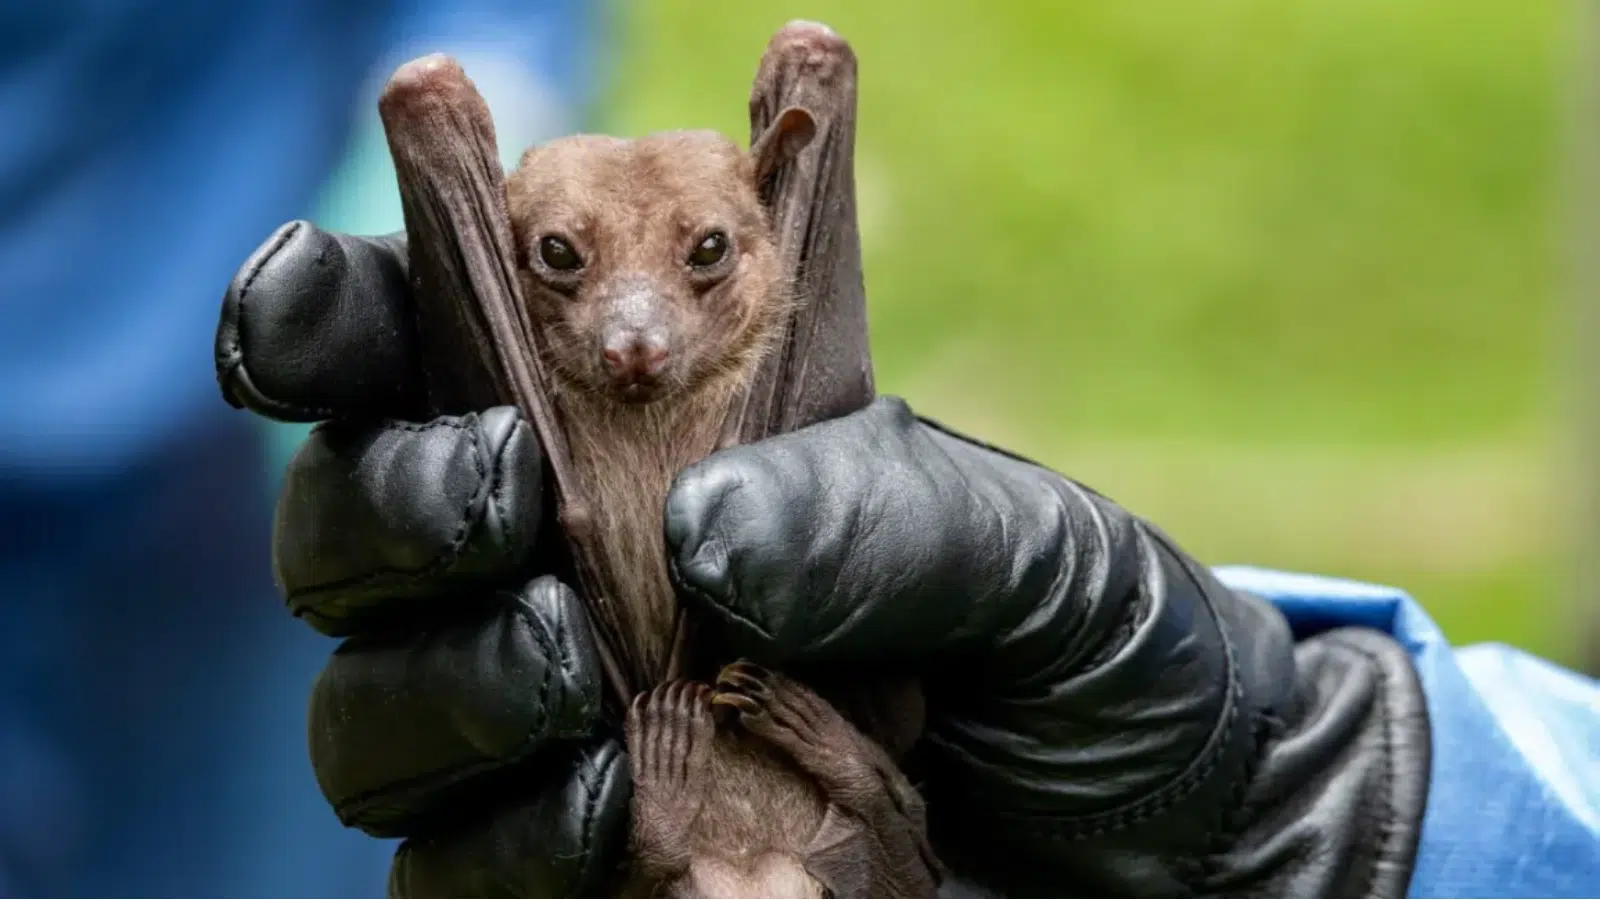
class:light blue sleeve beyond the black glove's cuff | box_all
[1216,567,1600,897]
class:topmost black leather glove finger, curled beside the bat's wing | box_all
[216,221,422,421]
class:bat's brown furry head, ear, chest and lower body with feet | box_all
[506,122,936,897]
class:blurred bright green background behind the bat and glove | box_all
[595,0,1576,661]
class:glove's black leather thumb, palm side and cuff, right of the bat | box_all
[667,399,1427,897]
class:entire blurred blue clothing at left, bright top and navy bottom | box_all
[0,0,594,897]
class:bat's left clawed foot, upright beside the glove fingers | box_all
[627,681,717,878]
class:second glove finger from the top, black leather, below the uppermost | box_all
[272,407,542,636]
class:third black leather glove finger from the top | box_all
[310,577,600,838]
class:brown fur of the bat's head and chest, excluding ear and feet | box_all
[506,131,790,684]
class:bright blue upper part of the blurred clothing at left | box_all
[0,0,595,479]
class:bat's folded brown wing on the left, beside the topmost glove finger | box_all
[378,54,630,701]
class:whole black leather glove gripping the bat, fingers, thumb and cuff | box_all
[218,223,1427,897]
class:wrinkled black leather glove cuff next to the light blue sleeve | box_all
[1198,628,1430,897]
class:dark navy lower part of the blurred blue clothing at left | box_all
[0,416,394,897]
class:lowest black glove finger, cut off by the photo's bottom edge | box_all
[389,740,632,897]
